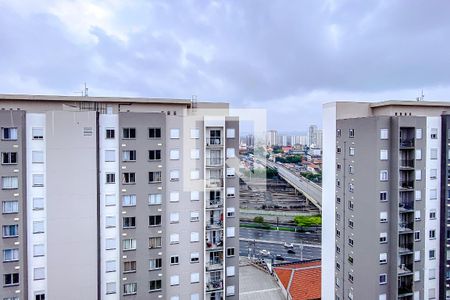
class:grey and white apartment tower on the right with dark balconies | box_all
[322,101,450,300]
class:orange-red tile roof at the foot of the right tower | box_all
[274,260,322,300]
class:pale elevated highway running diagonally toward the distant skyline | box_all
[258,159,322,210]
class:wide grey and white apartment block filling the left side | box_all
[0,95,239,300]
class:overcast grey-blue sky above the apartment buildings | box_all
[0,0,450,131]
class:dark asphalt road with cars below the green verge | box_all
[239,228,321,261]
